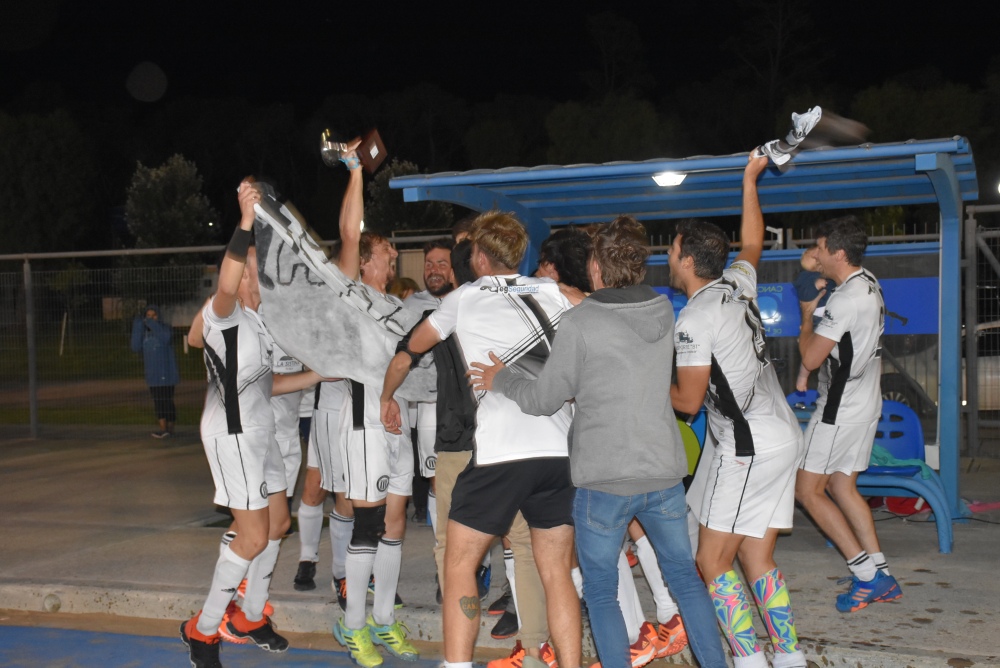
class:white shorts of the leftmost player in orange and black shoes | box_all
[202,431,287,510]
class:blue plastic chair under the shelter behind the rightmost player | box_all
[857,401,954,554]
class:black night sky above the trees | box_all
[0,0,1000,108]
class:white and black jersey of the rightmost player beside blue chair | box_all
[814,269,885,424]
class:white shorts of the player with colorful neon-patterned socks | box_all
[687,437,802,538]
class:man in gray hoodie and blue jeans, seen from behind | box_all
[470,216,726,668]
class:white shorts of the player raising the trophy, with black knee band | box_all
[341,420,413,502]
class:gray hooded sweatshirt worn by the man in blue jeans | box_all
[493,285,687,496]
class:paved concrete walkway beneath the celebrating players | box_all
[0,426,1000,668]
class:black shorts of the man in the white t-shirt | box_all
[448,457,575,536]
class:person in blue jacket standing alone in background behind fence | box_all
[132,306,180,438]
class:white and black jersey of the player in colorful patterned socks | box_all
[674,261,801,457]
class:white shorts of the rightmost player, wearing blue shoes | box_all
[801,418,878,475]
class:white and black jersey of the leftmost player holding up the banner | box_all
[201,297,274,439]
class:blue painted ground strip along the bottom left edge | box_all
[0,622,440,668]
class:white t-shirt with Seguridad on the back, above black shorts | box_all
[428,274,572,465]
